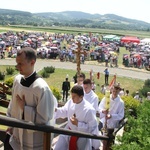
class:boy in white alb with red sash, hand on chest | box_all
[54,85,98,150]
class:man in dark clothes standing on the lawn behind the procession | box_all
[62,78,70,101]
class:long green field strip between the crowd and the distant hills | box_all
[0,25,150,38]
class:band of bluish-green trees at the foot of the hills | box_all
[0,16,150,32]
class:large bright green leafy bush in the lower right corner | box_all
[113,100,150,150]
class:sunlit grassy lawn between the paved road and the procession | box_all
[41,69,144,94]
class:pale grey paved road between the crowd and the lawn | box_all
[0,58,150,80]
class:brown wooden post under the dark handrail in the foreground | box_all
[43,132,51,150]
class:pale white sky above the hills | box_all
[0,0,150,23]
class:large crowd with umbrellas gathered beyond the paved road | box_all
[0,31,150,69]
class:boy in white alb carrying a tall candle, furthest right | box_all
[99,85,124,150]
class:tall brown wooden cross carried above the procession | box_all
[74,41,86,75]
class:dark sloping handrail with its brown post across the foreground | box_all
[0,115,109,150]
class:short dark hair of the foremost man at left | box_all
[17,47,37,61]
